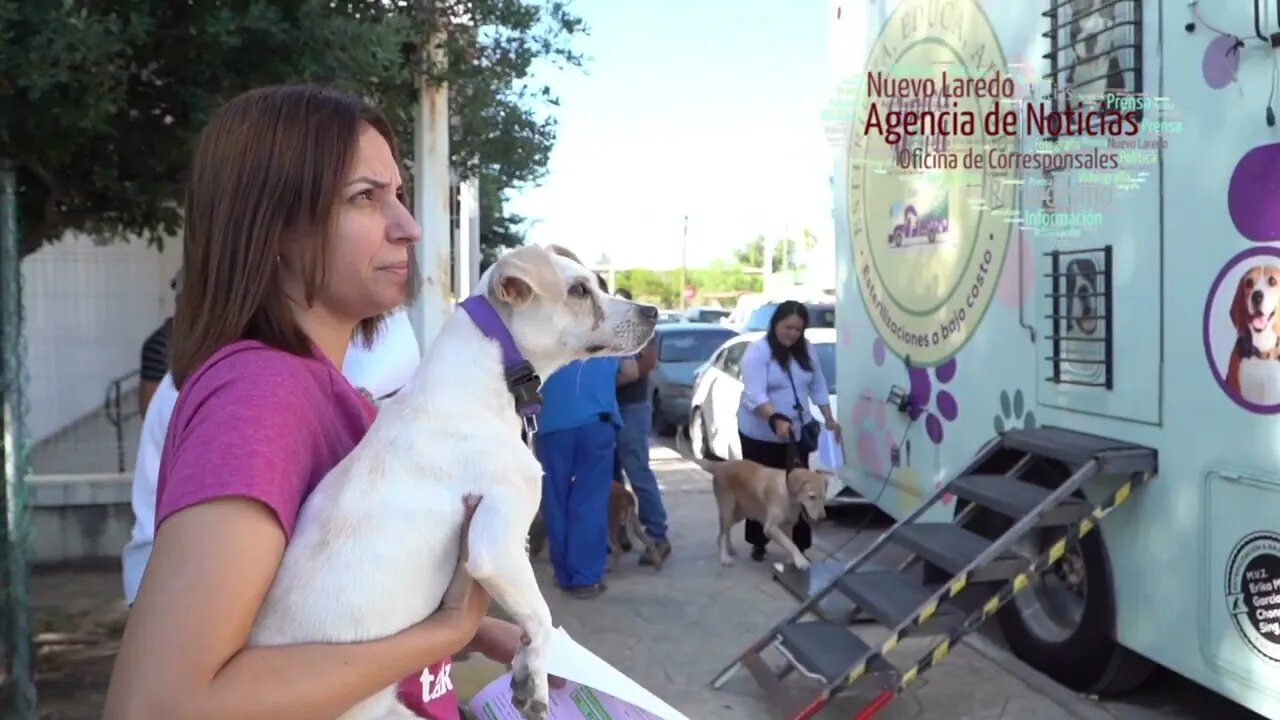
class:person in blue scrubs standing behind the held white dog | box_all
[534,269,640,598]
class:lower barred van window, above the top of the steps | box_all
[1044,245,1115,389]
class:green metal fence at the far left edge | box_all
[0,158,36,720]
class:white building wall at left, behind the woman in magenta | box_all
[22,233,182,442]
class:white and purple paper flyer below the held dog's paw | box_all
[467,628,689,720]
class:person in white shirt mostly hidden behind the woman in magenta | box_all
[120,303,421,605]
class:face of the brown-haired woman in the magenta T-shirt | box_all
[302,126,422,323]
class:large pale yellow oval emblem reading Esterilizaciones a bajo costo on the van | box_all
[846,0,1016,365]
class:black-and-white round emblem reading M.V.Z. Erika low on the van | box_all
[1226,532,1280,662]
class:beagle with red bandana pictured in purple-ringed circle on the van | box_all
[1226,265,1280,404]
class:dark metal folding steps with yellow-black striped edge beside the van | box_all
[712,428,1156,720]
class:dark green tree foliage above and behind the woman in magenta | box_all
[0,0,585,254]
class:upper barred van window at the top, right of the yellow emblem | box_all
[1041,0,1142,122]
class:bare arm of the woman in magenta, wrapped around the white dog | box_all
[104,498,488,720]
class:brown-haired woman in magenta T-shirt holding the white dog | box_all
[104,86,521,720]
